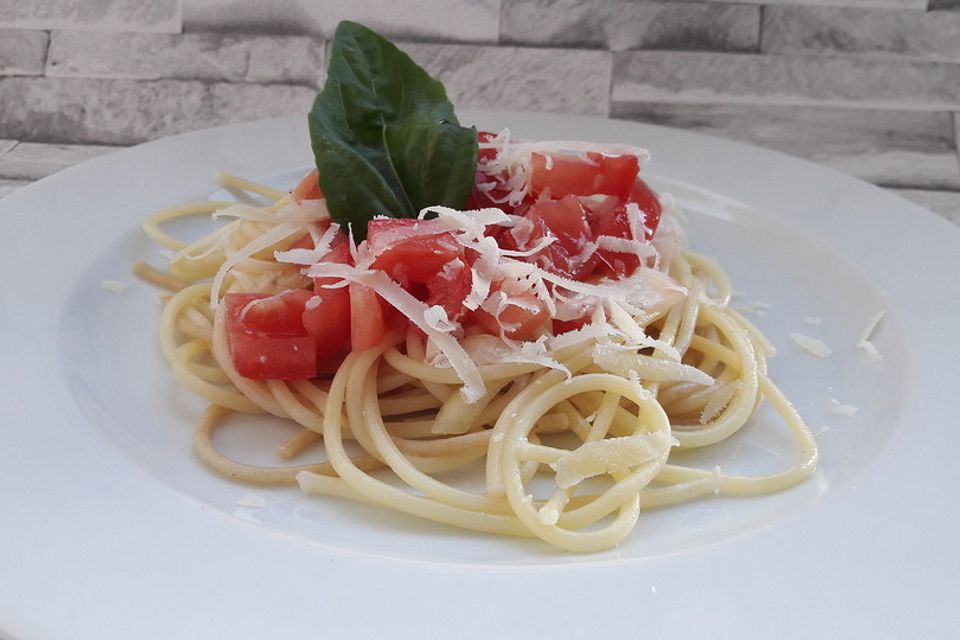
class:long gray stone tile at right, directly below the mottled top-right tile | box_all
[612,51,960,111]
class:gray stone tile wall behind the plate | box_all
[0,0,960,223]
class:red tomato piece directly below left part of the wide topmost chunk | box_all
[520,196,597,279]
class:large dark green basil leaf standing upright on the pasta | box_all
[308,21,477,240]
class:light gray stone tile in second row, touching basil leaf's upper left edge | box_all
[47,31,324,85]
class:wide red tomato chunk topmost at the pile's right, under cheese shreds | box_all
[530,153,640,199]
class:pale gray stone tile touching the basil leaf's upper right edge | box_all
[400,43,611,115]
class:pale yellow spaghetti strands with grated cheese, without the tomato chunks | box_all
[136,147,817,552]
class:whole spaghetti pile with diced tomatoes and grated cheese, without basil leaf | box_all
[138,127,817,552]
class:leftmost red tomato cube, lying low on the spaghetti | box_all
[223,290,317,380]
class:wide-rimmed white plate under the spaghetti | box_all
[0,112,960,639]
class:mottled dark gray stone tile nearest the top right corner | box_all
[763,7,960,62]
